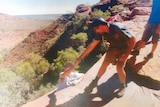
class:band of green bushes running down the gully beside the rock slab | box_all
[0,6,116,107]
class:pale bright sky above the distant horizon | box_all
[0,0,100,15]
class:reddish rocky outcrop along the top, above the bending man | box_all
[76,0,152,20]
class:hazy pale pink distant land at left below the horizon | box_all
[0,14,52,51]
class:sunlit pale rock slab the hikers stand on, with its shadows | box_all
[22,15,160,107]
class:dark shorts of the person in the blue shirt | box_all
[142,24,159,43]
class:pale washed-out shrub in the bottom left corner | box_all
[0,68,29,107]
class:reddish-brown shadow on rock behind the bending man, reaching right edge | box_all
[125,56,160,90]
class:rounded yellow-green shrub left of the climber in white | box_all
[16,53,50,89]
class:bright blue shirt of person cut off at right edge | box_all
[148,0,160,24]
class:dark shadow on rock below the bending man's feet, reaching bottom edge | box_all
[47,74,120,107]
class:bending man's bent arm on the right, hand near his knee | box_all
[119,36,136,61]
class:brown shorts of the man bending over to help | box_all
[105,48,126,65]
